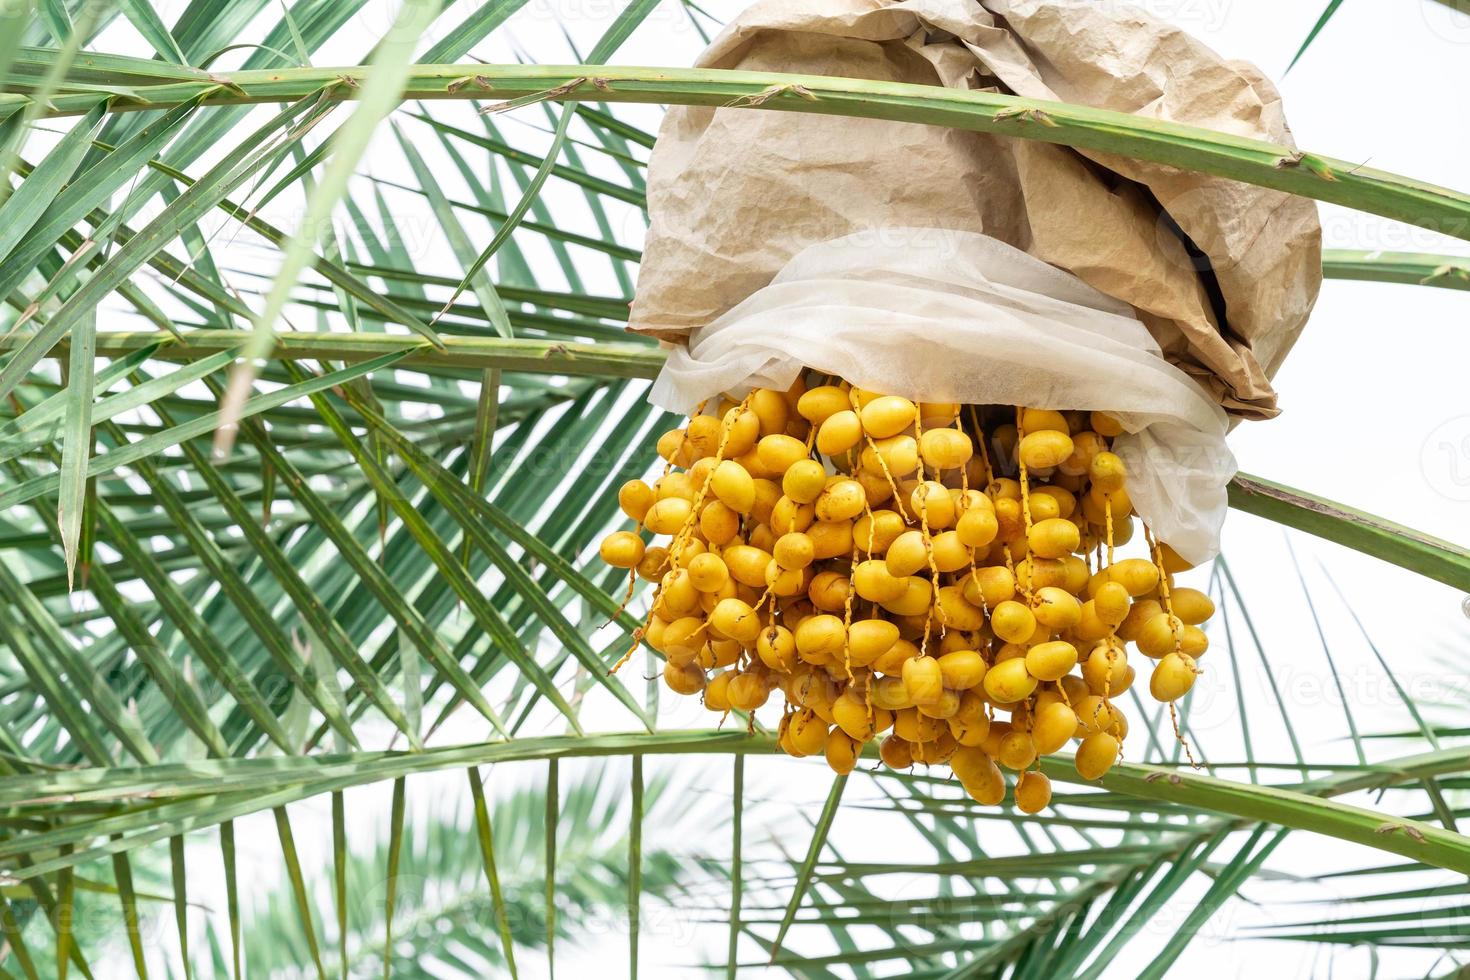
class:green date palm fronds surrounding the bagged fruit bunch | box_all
[0,0,1470,979]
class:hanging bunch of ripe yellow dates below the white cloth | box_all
[601,375,1214,813]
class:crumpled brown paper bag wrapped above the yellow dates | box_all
[631,0,1322,417]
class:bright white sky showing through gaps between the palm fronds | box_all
[71,0,1470,977]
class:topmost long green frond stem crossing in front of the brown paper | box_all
[17,65,1470,238]
